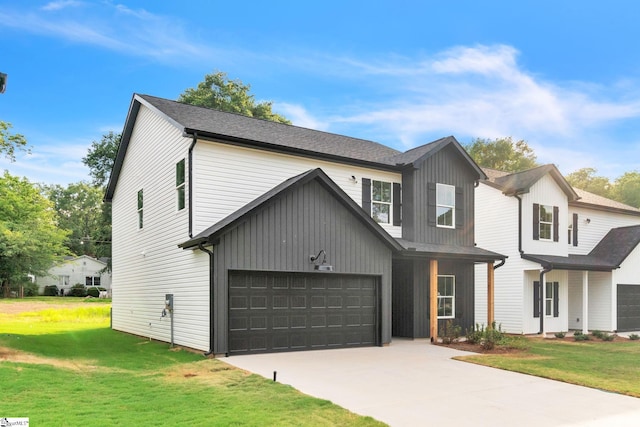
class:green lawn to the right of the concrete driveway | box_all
[460,339,640,397]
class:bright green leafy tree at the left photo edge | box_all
[0,171,67,296]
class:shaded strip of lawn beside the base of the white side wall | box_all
[0,328,202,370]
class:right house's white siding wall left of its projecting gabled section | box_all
[475,183,530,333]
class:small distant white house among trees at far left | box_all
[36,255,111,295]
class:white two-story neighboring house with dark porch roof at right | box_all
[475,165,640,334]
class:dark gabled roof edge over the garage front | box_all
[178,168,401,250]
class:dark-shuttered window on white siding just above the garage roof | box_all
[362,178,402,226]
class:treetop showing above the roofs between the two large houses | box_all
[464,136,538,172]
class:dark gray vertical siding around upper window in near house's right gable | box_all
[402,146,476,246]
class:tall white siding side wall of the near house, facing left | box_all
[112,106,209,350]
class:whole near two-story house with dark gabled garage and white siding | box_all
[106,95,505,355]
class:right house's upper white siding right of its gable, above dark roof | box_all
[564,207,640,255]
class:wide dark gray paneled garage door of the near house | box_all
[229,271,379,354]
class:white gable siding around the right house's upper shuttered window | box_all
[522,175,569,256]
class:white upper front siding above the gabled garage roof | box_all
[193,139,402,237]
